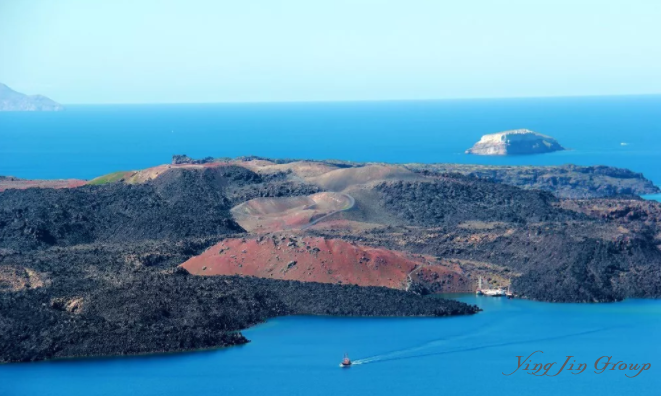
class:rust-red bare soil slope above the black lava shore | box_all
[181,235,470,291]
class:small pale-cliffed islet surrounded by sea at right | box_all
[466,129,565,155]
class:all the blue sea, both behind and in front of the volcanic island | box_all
[0,96,661,396]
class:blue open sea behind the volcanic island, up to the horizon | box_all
[0,96,661,184]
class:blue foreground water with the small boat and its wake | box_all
[0,296,661,396]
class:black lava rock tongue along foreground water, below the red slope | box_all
[0,264,477,363]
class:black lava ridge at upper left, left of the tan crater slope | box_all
[0,167,245,249]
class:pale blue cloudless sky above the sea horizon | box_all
[0,0,661,103]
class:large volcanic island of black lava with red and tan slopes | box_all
[0,155,661,363]
